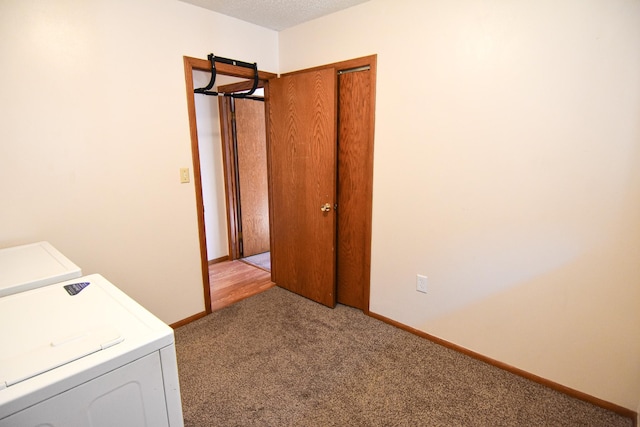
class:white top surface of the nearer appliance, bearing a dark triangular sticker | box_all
[0,274,174,419]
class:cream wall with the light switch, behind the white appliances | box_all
[0,0,278,323]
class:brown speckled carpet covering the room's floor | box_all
[176,288,632,427]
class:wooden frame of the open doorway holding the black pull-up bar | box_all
[183,56,277,314]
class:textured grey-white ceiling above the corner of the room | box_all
[181,0,368,31]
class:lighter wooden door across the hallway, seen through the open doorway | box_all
[234,98,269,257]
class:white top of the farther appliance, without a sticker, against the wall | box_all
[0,242,82,297]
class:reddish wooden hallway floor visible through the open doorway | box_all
[209,260,275,311]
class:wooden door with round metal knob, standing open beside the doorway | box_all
[268,68,337,307]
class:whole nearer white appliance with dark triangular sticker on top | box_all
[0,274,183,427]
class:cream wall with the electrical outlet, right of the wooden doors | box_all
[279,0,640,410]
